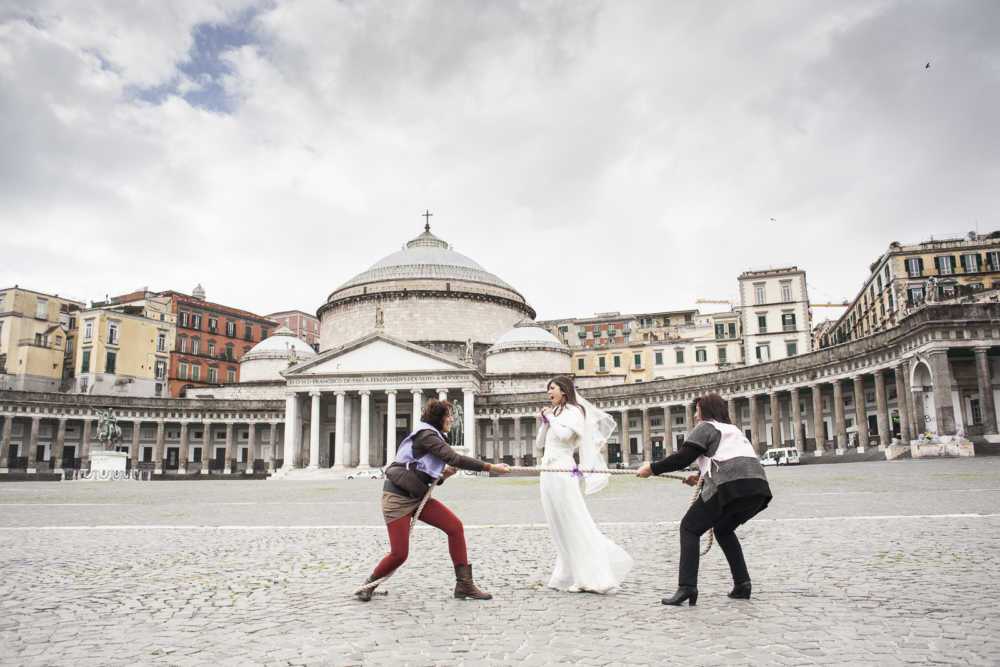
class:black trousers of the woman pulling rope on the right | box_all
[677,496,764,586]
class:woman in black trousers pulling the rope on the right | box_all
[638,394,771,605]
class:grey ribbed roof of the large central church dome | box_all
[334,225,520,296]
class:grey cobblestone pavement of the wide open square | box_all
[0,458,1000,665]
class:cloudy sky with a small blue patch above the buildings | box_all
[0,0,1000,318]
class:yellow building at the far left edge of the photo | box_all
[0,286,84,391]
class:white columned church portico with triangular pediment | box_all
[283,333,481,469]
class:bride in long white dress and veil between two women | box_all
[535,375,633,593]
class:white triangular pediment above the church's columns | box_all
[283,334,474,378]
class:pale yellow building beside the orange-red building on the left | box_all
[74,304,176,396]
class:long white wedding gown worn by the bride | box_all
[535,406,633,593]
